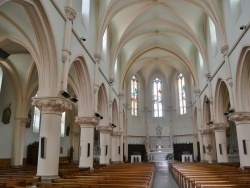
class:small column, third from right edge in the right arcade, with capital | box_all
[201,129,213,163]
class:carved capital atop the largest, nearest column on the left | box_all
[31,97,72,114]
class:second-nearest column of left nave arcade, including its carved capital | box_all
[76,117,99,169]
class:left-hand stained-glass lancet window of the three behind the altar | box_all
[131,76,138,116]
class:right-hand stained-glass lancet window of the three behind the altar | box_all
[178,73,187,115]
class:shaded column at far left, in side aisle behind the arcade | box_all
[11,118,30,167]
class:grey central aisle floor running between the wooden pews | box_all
[153,162,179,188]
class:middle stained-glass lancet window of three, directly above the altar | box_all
[153,78,162,117]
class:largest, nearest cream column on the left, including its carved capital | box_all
[32,97,72,181]
